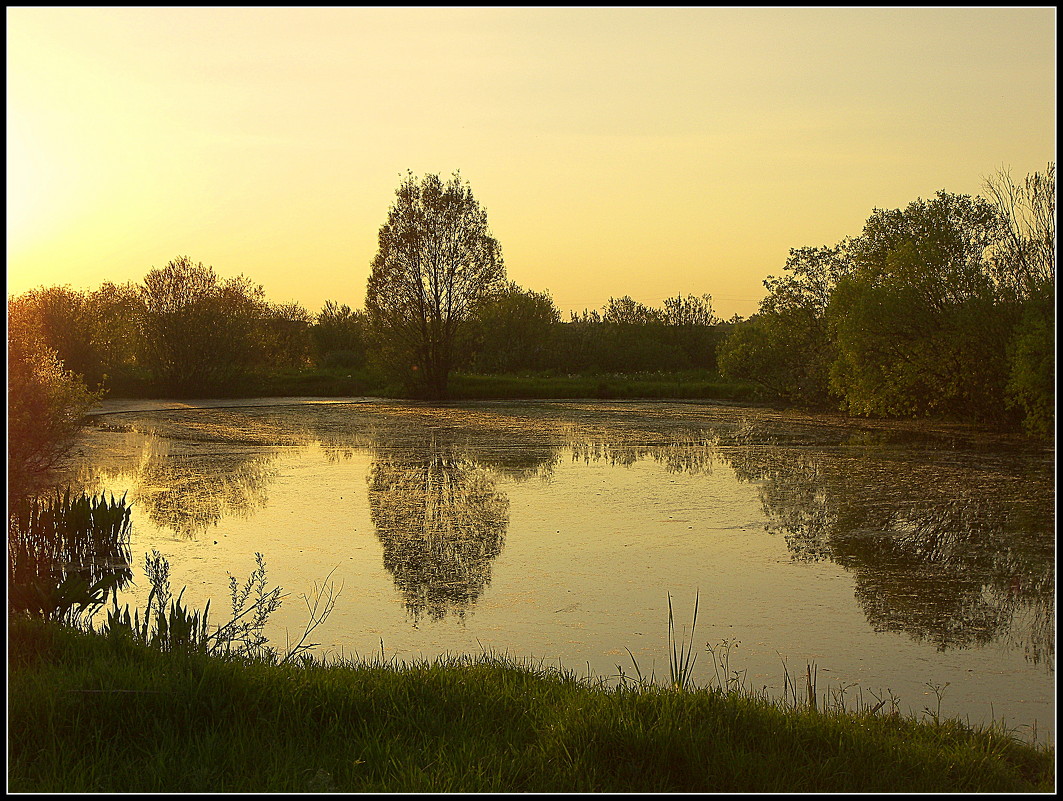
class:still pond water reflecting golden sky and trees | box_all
[66,399,1056,740]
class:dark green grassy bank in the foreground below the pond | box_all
[9,618,1054,793]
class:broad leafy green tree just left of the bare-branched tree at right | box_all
[827,191,1011,421]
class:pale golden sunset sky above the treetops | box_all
[6,6,1056,317]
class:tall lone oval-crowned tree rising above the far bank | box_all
[366,172,505,399]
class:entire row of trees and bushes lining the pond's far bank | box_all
[7,164,1056,497]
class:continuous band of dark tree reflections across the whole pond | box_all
[68,404,1054,668]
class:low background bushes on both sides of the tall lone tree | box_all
[7,256,729,390]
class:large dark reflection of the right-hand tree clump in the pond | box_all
[727,446,1056,669]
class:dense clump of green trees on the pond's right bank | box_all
[719,164,1056,438]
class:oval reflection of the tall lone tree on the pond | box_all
[368,442,509,621]
